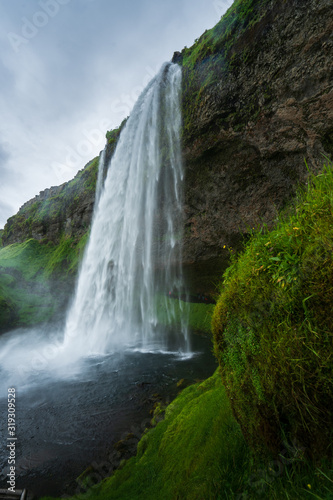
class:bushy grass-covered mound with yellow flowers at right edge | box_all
[213,160,333,462]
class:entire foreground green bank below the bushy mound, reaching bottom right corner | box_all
[44,371,332,500]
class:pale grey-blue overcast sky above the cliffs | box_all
[0,0,232,228]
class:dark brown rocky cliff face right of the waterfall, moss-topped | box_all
[179,0,333,261]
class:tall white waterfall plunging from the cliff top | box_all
[64,63,186,354]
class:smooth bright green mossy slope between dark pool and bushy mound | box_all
[41,372,247,500]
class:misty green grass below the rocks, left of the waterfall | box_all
[0,233,88,329]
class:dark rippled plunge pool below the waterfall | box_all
[0,335,216,497]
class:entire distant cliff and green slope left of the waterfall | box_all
[0,128,123,332]
